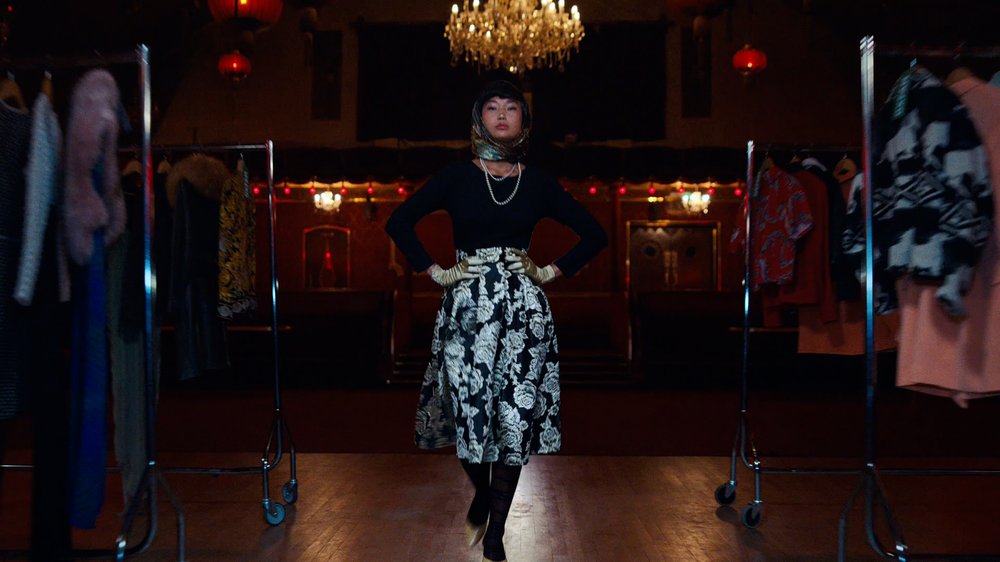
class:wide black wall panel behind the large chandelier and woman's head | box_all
[358,23,667,141]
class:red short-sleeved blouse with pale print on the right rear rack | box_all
[730,167,813,291]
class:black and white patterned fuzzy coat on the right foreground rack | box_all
[843,67,993,316]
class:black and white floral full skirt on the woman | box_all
[416,248,562,465]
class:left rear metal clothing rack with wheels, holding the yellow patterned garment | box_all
[141,139,299,525]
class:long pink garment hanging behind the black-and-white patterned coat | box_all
[896,78,1000,407]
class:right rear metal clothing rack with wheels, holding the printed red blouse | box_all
[715,140,861,529]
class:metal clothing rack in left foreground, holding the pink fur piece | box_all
[0,44,185,560]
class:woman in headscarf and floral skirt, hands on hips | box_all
[386,81,607,560]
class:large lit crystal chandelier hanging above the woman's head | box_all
[444,0,583,74]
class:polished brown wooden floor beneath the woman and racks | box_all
[0,454,1000,561]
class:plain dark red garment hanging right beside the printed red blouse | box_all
[763,166,838,326]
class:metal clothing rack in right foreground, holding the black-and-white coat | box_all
[837,35,1000,561]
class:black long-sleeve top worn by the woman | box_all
[385,160,608,277]
